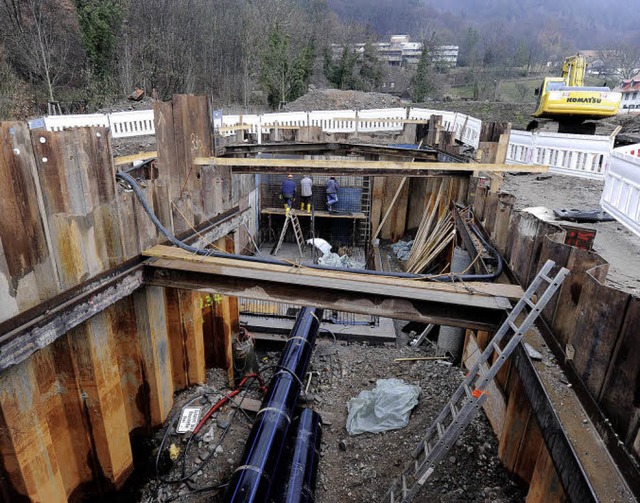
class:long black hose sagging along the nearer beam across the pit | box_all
[116,171,502,282]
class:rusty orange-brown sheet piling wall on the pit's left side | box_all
[0,96,255,502]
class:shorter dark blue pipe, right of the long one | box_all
[275,409,322,503]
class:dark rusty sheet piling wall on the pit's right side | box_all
[470,180,640,500]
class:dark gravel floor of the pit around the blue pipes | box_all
[131,315,526,503]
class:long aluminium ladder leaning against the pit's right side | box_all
[382,260,569,503]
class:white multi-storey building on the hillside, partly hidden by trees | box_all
[331,35,458,67]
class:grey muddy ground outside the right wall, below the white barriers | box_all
[502,174,640,295]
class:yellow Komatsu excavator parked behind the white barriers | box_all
[533,54,622,122]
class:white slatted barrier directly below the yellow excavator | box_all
[507,130,614,180]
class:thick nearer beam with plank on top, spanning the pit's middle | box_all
[145,246,522,330]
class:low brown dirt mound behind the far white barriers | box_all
[285,89,403,112]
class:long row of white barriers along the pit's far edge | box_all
[36,108,482,148]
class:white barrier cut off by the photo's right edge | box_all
[600,144,640,236]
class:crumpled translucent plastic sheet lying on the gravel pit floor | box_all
[347,379,420,435]
